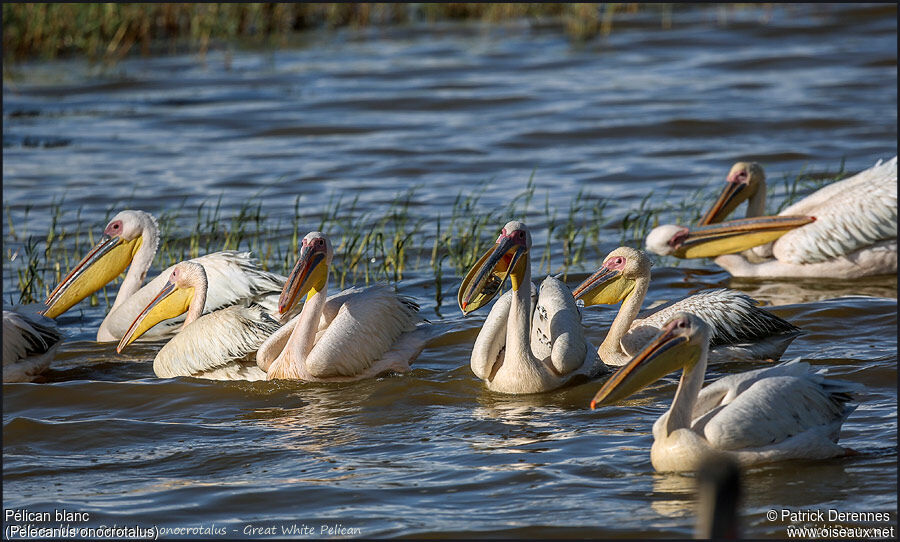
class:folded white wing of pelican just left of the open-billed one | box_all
[306,284,419,378]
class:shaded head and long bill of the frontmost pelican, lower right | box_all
[591,312,710,408]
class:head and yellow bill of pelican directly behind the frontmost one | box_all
[572,247,651,307]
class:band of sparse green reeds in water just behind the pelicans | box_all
[3,166,846,307]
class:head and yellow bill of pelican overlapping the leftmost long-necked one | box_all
[116,261,207,352]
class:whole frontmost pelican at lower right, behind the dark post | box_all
[591,312,860,472]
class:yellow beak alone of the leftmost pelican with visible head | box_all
[43,235,143,318]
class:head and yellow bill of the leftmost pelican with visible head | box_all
[43,210,156,318]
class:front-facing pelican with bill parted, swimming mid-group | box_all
[457,221,607,394]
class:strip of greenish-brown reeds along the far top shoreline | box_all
[3,2,769,63]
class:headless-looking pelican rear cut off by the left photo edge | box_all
[3,309,62,382]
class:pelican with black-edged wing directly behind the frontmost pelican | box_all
[573,247,800,365]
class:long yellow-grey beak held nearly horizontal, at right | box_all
[669,216,816,258]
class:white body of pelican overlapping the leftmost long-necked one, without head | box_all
[153,304,280,380]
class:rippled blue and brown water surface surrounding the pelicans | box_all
[3,5,897,537]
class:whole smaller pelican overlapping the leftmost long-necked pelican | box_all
[116,261,280,380]
